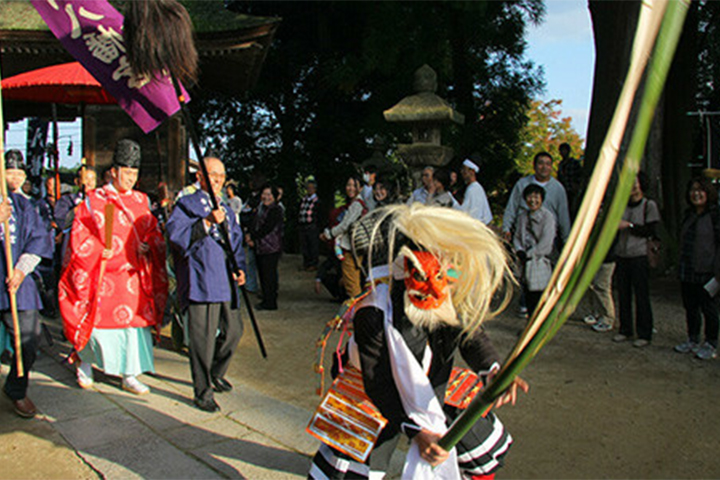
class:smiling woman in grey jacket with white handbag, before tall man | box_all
[513,183,557,315]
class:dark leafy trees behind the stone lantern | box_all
[193,0,544,249]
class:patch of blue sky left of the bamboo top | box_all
[527,0,595,142]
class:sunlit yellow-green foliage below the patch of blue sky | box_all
[516,100,583,175]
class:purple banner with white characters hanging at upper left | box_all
[32,0,189,133]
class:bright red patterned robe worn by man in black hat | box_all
[58,185,168,351]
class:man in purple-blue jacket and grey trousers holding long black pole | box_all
[166,157,245,412]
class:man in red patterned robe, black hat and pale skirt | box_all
[59,139,167,395]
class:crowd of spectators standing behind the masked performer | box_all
[296,143,720,359]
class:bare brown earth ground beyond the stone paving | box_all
[230,255,720,479]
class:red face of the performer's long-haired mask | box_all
[405,251,448,310]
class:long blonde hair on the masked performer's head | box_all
[368,203,514,335]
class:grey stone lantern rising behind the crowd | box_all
[383,65,465,181]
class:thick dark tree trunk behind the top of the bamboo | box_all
[585,0,698,270]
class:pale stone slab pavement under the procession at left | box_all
[0,320,317,479]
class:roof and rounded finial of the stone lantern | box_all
[383,64,465,124]
